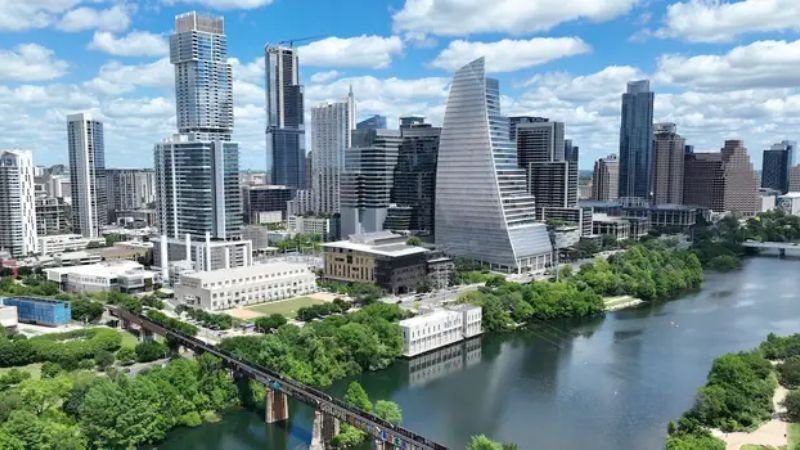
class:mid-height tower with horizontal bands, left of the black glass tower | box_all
[340,129,402,236]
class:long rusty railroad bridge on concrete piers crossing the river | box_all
[108,306,448,450]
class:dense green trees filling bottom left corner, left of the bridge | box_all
[0,355,240,450]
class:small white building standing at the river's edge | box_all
[398,305,482,357]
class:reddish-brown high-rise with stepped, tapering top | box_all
[683,140,761,216]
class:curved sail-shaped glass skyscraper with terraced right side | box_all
[435,58,553,272]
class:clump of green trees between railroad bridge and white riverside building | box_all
[220,303,404,386]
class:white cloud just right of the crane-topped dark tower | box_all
[298,35,403,69]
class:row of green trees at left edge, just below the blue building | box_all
[0,328,122,369]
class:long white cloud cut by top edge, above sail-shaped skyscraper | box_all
[392,0,637,36]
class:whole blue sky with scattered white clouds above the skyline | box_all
[0,0,800,170]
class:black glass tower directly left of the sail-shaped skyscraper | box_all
[392,117,442,234]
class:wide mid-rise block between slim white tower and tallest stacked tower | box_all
[106,169,156,223]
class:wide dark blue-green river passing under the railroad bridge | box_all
[158,258,800,450]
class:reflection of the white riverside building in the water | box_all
[408,336,481,386]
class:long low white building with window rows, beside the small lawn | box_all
[175,262,317,311]
